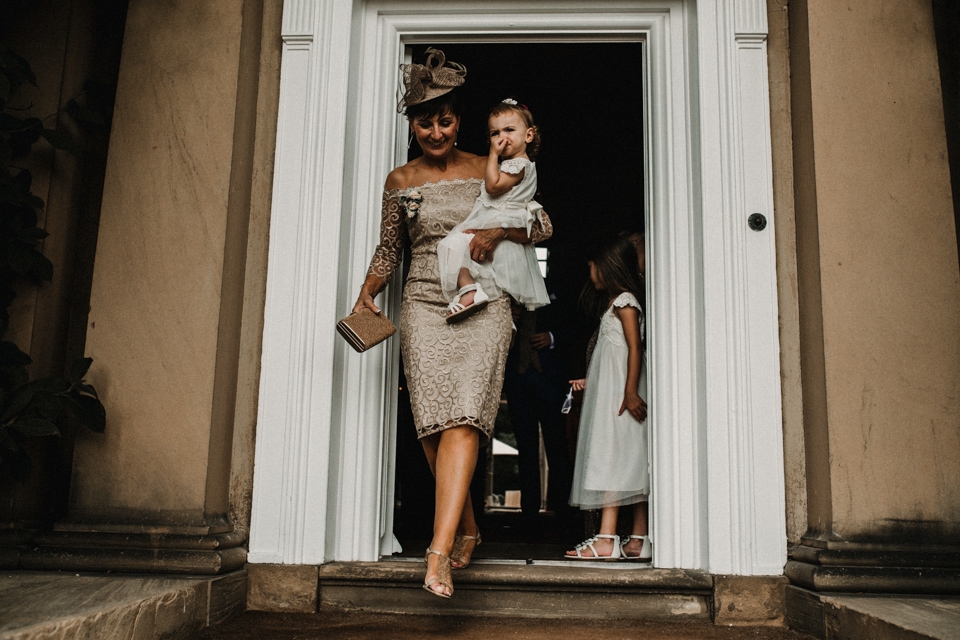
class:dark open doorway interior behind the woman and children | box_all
[394,42,645,559]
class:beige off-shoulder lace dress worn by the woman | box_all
[367,179,553,438]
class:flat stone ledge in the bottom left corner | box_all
[0,570,247,640]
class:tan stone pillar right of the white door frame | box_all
[790,0,960,545]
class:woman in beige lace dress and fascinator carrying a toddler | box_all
[353,49,552,598]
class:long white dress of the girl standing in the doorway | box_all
[570,293,650,509]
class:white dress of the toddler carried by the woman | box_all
[437,158,550,310]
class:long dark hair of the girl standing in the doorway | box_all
[580,235,647,332]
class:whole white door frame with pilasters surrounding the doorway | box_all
[249,0,786,575]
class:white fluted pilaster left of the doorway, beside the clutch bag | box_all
[249,0,351,564]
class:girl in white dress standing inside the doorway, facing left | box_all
[565,237,651,562]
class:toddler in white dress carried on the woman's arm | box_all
[437,98,550,323]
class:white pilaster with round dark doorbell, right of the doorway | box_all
[698,0,786,575]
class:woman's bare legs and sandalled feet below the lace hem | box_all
[420,426,480,592]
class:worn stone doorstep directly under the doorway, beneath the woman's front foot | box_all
[318,559,714,622]
